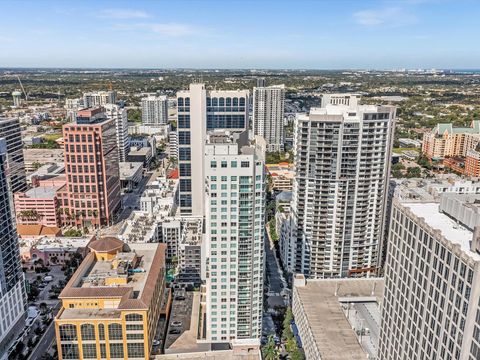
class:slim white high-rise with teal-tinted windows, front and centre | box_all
[202,131,265,342]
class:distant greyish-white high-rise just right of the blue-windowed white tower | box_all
[253,85,285,151]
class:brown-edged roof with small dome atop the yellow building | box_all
[59,237,166,310]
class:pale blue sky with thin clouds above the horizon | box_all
[0,0,480,69]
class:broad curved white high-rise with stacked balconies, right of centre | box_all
[284,95,395,278]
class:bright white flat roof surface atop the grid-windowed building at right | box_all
[402,202,480,261]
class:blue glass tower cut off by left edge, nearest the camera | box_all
[0,139,27,358]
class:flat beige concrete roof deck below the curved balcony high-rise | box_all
[294,278,384,360]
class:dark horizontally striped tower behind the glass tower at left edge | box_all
[0,118,27,193]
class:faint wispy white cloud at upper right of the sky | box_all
[353,7,417,27]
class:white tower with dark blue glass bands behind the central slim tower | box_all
[177,84,249,216]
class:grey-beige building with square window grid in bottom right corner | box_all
[378,192,480,360]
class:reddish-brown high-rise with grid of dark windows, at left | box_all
[61,108,121,227]
